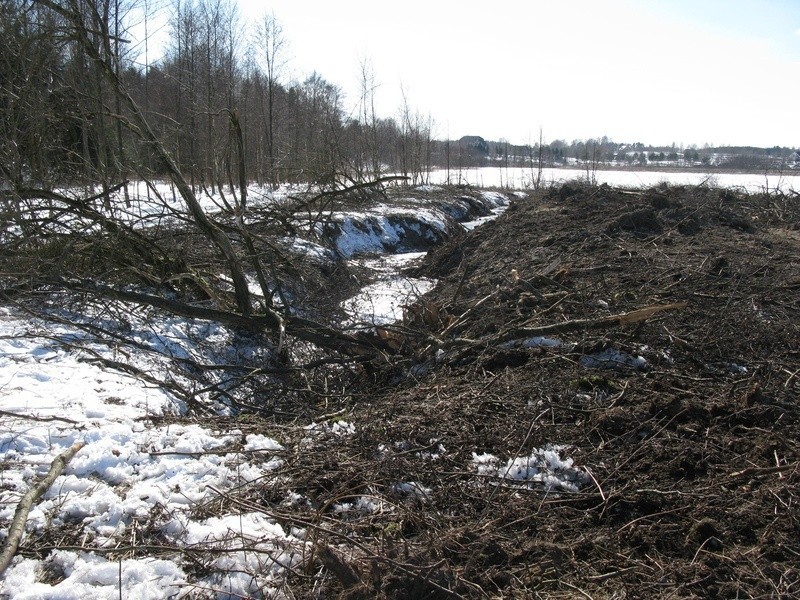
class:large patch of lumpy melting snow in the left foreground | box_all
[0,309,296,599]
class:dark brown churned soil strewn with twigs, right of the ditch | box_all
[280,185,800,599]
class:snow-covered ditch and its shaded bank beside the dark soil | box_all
[292,186,512,330]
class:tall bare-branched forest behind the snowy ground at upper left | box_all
[0,0,432,189]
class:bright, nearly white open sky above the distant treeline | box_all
[233,0,800,146]
